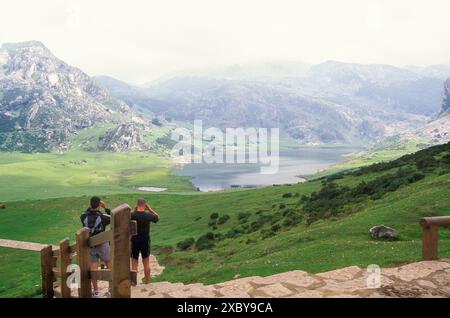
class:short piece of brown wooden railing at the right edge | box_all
[420,216,450,261]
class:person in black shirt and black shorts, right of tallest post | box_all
[131,199,160,284]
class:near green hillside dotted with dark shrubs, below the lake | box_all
[0,145,450,297]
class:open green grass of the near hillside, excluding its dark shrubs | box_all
[0,143,450,297]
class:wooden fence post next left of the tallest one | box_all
[76,227,91,298]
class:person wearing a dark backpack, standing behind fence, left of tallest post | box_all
[80,197,111,298]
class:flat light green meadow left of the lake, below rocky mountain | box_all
[0,150,194,202]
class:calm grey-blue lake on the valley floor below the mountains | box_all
[174,147,361,192]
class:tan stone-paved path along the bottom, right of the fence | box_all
[132,259,450,298]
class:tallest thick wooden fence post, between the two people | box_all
[111,204,131,298]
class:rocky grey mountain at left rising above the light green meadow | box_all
[0,41,153,152]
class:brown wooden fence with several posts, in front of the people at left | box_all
[41,204,137,298]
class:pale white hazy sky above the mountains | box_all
[0,0,450,83]
